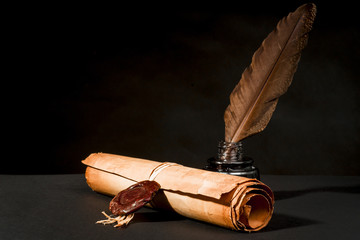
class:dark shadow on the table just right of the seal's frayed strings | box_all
[132,211,186,224]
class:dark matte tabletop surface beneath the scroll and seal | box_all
[0,174,360,240]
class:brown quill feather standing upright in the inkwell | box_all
[224,3,316,142]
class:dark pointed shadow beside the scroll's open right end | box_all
[261,213,320,232]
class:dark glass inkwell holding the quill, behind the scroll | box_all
[205,141,260,179]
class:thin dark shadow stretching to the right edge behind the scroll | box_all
[274,185,360,201]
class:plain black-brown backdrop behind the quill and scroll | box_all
[4,1,360,175]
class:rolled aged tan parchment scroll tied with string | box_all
[83,153,274,231]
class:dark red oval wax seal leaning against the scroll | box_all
[109,181,160,215]
